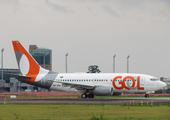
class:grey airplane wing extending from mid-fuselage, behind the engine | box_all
[55,81,95,90]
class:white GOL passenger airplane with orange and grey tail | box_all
[9,40,167,98]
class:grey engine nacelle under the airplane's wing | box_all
[93,86,113,95]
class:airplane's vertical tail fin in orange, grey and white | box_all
[12,41,49,82]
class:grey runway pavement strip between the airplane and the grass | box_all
[0,97,170,104]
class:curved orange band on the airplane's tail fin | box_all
[12,41,40,82]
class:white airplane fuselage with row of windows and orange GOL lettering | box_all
[50,73,166,92]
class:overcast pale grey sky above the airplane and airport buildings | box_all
[0,0,170,78]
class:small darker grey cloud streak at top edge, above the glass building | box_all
[46,0,68,13]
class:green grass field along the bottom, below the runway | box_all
[0,104,170,120]
